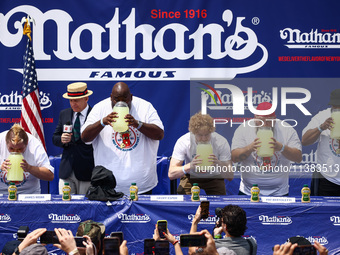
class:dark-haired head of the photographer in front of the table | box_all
[222,205,247,237]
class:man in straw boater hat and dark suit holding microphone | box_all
[52,82,94,194]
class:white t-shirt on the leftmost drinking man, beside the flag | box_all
[0,131,54,194]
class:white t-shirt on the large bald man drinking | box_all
[81,96,164,194]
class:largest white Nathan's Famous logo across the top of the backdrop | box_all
[0,5,268,80]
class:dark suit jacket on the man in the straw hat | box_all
[52,107,94,181]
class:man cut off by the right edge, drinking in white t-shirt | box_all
[302,89,340,196]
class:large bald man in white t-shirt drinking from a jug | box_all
[81,82,164,194]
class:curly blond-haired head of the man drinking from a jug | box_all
[189,112,215,143]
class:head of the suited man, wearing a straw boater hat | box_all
[63,82,93,112]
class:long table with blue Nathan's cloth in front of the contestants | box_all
[0,195,340,254]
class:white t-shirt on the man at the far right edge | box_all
[302,108,340,185]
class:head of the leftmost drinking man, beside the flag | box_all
[6,124,28,153]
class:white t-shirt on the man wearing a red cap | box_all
[231,120,302,196]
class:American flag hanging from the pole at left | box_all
[21,26,46,150]
